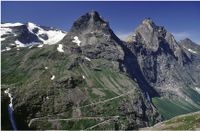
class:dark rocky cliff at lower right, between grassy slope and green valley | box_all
[120,92,163,130]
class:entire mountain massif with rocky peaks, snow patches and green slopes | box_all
[1,11,200,130]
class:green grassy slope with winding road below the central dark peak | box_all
[2,45,142,129]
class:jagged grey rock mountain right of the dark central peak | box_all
[126,19,199,97]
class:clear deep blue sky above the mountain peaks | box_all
[1,1,200,44]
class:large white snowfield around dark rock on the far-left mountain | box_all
[0,22,66,47]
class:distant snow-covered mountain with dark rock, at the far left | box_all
[1,22,66,48]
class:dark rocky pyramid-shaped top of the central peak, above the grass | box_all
[60,12,124,60]
